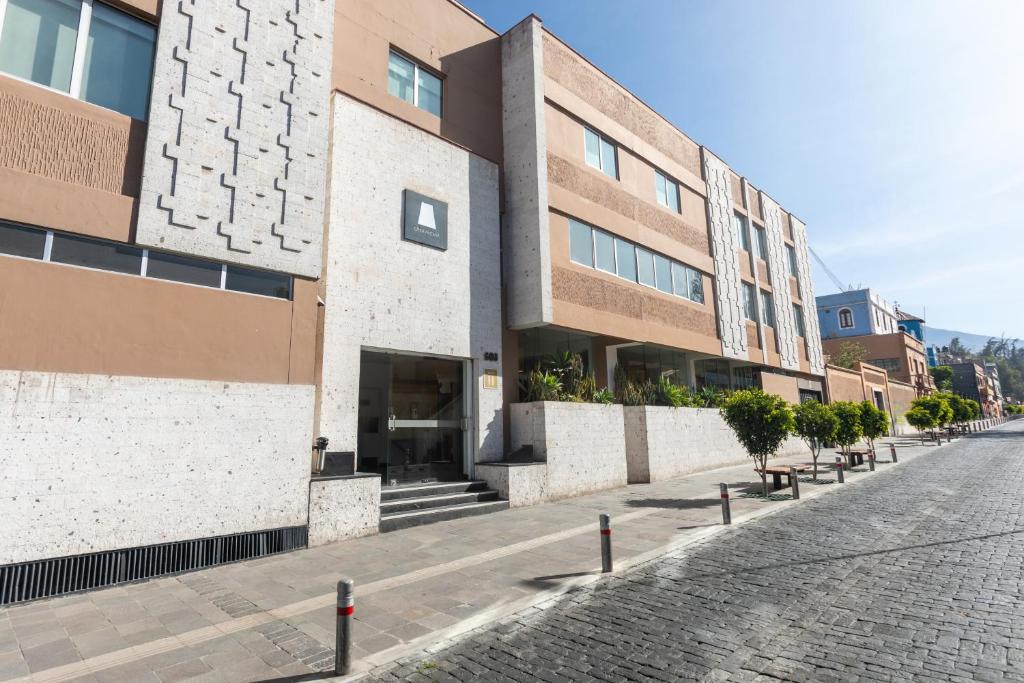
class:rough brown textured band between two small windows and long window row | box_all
[548,153,709,254]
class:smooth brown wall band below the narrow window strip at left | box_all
[0,256,316,384]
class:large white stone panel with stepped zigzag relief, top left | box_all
[137,0,334,276]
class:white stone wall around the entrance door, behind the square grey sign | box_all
[321,93,502,461]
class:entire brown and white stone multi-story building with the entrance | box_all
[0,0,823,602]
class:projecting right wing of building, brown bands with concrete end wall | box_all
[502,16,823,400]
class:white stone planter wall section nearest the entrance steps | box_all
[509,401,627,500]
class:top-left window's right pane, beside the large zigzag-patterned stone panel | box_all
[82,2,157,121]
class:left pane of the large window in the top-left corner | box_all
[0,0,82,92]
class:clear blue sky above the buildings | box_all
[463,0,1024,338]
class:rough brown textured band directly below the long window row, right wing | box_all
[551,267,716,337]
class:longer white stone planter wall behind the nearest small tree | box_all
[624,405,810,483]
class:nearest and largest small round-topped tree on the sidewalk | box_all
[721,389,796,498]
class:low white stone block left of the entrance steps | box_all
[309,474,381,547]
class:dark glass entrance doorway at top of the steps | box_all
[356,351,467,485]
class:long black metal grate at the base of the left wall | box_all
[0,526,308,605]
